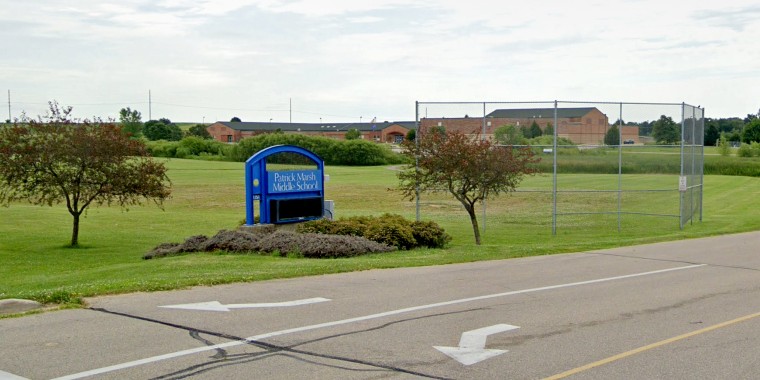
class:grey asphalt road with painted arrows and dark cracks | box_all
[0,232,760,380]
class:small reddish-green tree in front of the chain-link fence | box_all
[398,132,538,245]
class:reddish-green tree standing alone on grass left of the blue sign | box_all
[0,102,170,246]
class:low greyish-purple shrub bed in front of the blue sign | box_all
[143,227,396,260]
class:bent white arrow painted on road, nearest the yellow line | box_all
[433,323,520,365]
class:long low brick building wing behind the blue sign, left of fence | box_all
[206,121,415,143]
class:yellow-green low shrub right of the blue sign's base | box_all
[297,214,451,249]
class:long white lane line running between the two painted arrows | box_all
[53,264,707,380]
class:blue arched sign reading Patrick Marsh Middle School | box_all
[245,145,325,226]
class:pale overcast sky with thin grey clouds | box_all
[0,0,760,123]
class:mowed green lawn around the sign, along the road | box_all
[0,160,760,301]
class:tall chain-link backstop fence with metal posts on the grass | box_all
[416,101,704,235]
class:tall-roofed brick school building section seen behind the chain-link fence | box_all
[420,107,639,145]
